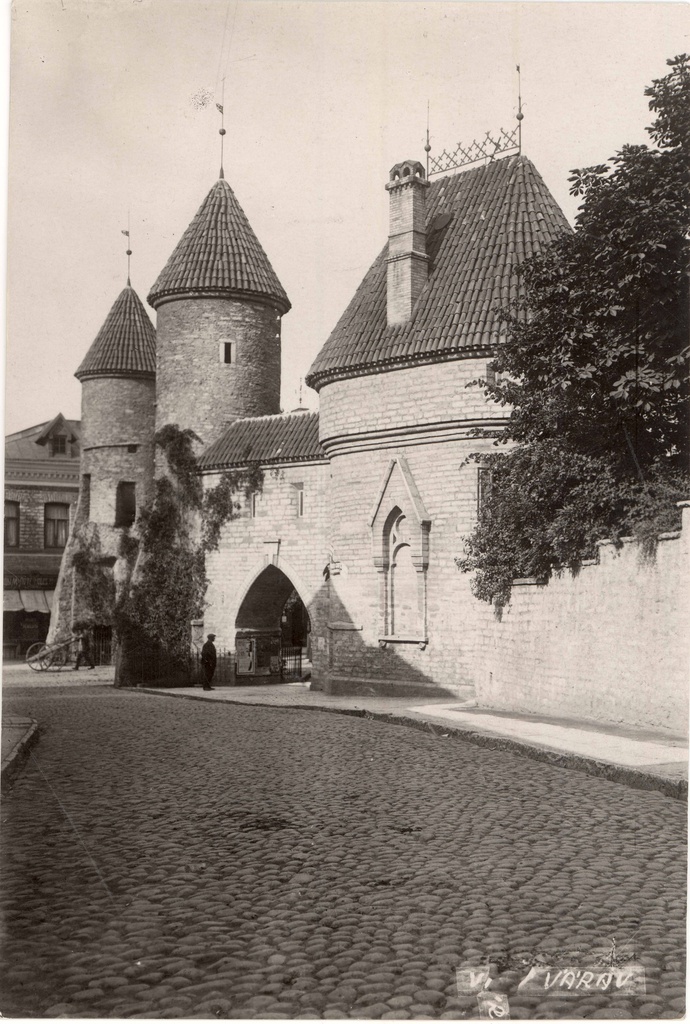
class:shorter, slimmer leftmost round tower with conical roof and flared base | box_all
[48,282,156,642]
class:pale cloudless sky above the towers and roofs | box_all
[5,0,690,432]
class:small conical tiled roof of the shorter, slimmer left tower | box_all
[75,285,156,380]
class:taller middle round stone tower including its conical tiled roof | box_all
[148,177,290,445]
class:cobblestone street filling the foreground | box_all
[0,684,687,1020]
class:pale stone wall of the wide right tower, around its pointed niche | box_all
[319,358,506,698]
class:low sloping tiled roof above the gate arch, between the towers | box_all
[200,412,326,469]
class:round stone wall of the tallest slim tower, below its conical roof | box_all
[156,299,281,446]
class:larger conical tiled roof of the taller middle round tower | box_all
[148,178,290,313]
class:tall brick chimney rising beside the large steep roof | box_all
[386,160,429,327]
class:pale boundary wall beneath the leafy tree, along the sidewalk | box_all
[473,509,690,734]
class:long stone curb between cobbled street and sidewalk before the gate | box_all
[134,687,688,802]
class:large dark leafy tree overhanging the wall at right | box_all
[458,54,690,601]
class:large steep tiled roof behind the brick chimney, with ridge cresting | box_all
[306,156,570,389]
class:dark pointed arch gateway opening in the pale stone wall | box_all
[234,565,311,682]
